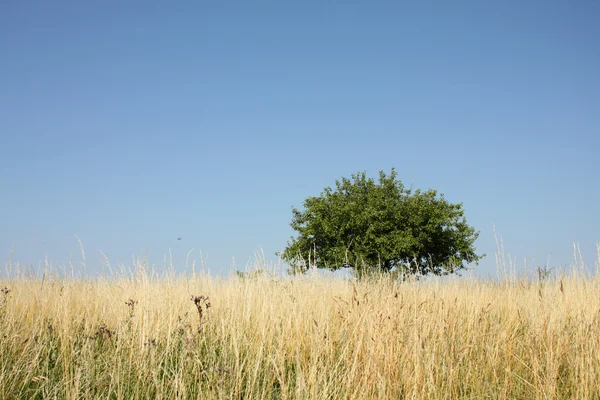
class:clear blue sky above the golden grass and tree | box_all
[0,0,600,275]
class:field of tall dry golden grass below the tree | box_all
[0,252,600,399]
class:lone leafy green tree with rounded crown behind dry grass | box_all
[280,168,483,278]
